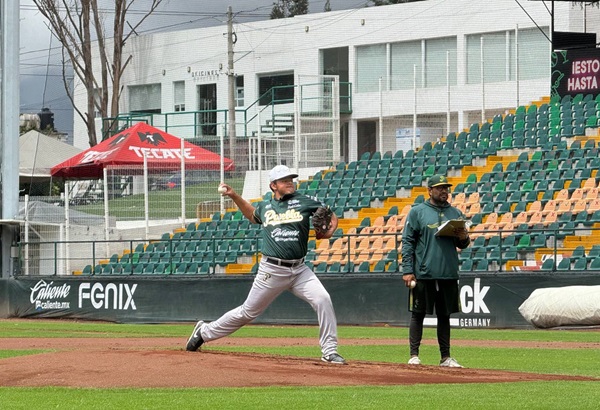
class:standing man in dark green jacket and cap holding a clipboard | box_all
[402,175,470,367]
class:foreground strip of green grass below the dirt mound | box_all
[0,382,600,410]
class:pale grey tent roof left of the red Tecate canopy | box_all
[19,130,82,182]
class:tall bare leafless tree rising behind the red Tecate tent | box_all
[33,0,163,147]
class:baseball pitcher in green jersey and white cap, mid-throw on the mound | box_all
[186,165,346,364]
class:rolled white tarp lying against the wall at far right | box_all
[519,286,600,328]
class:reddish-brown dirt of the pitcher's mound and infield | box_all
[0,338,600,388]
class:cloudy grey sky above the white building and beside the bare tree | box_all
[20,0,368,140]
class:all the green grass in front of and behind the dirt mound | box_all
[0,320,600,410]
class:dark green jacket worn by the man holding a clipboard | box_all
[402,200,470,280]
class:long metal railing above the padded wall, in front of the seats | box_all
[17,227,600,276]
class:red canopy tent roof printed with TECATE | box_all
[50,122,234,179]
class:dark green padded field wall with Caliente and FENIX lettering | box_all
[0,273,600,328]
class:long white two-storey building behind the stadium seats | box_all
[74,0,600,167]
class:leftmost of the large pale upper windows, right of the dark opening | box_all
[356,44,387,93]
